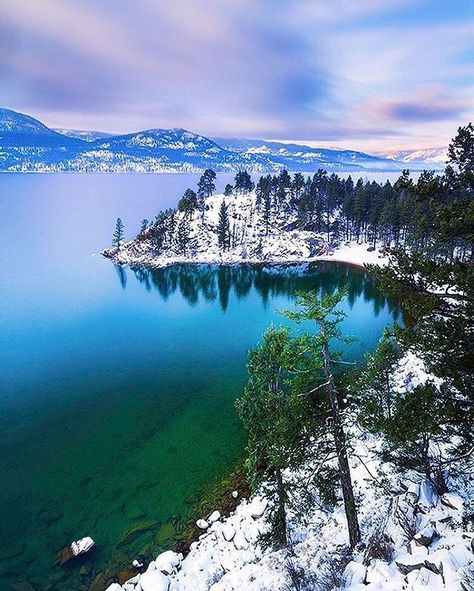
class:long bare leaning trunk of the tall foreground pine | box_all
[321,342,360,548]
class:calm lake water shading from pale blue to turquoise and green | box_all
[0,175,398,591]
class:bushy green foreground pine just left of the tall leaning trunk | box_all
[236,327,305,548]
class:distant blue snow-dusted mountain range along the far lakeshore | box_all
[0,109,442,172]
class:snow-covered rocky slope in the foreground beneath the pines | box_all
[108,353,474,591]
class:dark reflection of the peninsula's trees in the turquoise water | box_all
[118,263,401,320]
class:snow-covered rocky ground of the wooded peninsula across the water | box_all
[103,192,386,267]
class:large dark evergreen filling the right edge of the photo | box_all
[370,126,474,471]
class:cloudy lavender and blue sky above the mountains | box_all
[0,0,474,152]
